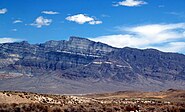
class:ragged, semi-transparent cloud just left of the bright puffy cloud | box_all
[30,16,52,28]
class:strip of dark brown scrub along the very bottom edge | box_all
[0,103,185,112]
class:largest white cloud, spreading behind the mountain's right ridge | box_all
[90,23,185,53]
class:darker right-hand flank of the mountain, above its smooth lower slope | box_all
[63,48,185,83]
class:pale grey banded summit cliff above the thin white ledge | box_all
[39,37,115,57]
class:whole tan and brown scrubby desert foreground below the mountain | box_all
[0,90,185,112]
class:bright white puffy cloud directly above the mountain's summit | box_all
[66,14,102,25]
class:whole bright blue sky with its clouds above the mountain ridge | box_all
[0,0,185,53]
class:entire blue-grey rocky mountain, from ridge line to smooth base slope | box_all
[0,37,185,94]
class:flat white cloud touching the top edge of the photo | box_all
[114,0,147,7]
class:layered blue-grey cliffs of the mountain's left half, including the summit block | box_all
[0,37,115,75]
